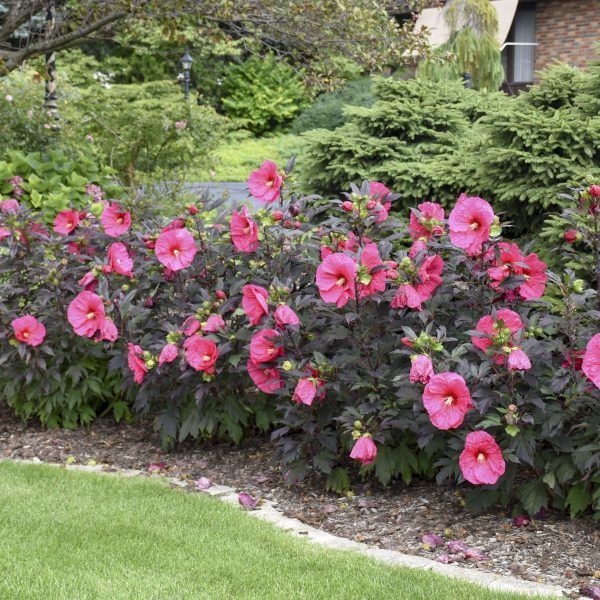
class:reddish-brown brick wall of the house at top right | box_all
[535,0,600,77]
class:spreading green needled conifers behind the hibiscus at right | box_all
[301,58,600,233]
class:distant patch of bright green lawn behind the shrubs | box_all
[198,133,301,181]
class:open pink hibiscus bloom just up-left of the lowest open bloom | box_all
[423,372,473,429]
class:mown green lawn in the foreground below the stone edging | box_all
[0,462,552,600]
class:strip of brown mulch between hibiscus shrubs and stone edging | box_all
[0,405,600,597]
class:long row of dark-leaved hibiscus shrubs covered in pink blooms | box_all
[0,161,600,516]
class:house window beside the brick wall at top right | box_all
[502,5,535,85]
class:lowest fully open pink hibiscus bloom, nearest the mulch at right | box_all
[458,431,506,485]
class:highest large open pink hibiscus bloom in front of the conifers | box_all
[448,194,494,254]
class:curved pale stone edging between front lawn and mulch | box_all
[5,459,568,598]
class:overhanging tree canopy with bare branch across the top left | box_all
[0,0,426,81]
